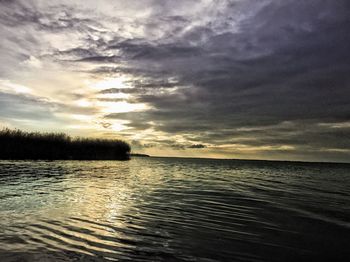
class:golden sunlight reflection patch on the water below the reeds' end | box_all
[53,161,162,234]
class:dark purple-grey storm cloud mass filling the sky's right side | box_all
[98,1,350,160]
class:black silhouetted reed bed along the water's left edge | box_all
[0,128,130,160]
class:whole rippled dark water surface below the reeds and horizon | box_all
[0,158,350,261]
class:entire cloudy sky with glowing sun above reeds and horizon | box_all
[0,0,350,162]
